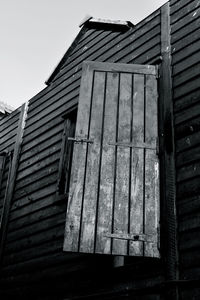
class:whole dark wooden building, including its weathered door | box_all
[0,0,200,300]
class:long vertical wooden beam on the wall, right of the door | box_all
[159,2,179,299]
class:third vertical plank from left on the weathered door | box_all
[96,72,119,254]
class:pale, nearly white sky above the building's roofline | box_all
[0,0,167,108]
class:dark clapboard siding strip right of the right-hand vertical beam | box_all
[171,0,200,292]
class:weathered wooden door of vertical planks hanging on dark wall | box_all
[64,62,159,257]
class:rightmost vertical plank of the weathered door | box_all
[144,75,160,257]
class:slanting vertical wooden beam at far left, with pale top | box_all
[0,103,27,265]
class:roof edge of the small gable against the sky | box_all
[45,15,134,85]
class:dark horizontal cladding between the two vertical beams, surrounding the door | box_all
[1,10,162,299]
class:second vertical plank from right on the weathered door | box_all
[129,74,145,255]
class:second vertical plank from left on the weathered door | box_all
[80,72,106,253]
